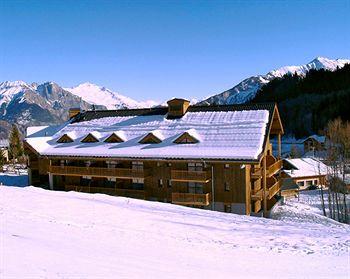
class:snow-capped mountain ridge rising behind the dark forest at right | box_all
[200,57,350,104]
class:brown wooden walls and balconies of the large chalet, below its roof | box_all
[25,103,283,216]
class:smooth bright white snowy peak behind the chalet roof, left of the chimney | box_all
[65,82,157,109]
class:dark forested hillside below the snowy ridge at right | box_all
[251,64,350,138]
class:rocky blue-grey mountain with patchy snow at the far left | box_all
[0,81,93,135]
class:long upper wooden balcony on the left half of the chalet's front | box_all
[49,166,150,179]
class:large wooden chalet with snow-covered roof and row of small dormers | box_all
[25,99,283,216]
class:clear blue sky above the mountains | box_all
[0,0,350,100]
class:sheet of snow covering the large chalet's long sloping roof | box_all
[26,109,269,160]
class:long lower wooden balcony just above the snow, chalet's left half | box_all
[65,185,145,199]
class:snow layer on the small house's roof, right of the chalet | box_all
[284,158,327,178]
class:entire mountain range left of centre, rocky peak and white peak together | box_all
[0,81,157,137]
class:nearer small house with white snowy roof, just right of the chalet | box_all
[282,158,327,190]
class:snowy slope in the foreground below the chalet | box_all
[0,182,350,279]
